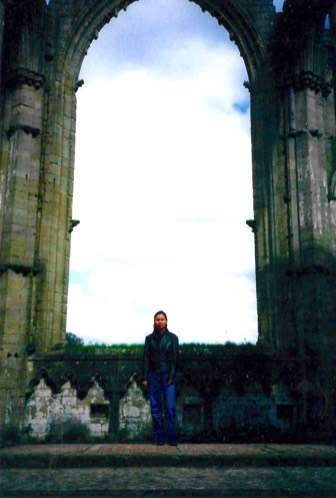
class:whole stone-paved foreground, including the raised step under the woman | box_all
[0,445,336,498]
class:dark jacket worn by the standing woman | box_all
[144,329,179,380]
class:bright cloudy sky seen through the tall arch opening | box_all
[67,0,283,344]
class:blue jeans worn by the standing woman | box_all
[149,373,176,442]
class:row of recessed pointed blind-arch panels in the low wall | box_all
[25,379,295,442]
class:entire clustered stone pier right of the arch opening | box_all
[251,2,336,362]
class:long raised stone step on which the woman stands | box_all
[0,444,336,469]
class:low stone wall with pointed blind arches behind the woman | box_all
[25,352,330,442]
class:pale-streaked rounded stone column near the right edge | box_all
[286,73,335,354]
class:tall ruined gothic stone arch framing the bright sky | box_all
[0,0,336,428]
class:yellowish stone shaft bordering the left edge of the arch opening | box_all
[37,81,76,351]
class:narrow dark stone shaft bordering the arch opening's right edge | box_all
[249,76,286,350]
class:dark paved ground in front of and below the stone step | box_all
[1,467,336,498]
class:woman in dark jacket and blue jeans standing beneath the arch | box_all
[142,310,179,446]
